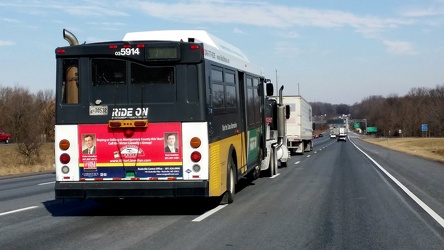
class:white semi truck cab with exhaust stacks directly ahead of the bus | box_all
[261,84,291,176]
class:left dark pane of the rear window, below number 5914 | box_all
[92,59,126,85]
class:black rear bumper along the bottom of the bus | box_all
[55,181,209,199]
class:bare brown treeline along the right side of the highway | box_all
[312,84,444,137]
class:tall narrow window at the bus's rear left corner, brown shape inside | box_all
[62,60,79,104]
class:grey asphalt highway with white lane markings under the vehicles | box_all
[0,134,444,250]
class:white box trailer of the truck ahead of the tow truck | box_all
[283,95,313,154]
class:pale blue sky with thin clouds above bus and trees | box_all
[0,0,444,105]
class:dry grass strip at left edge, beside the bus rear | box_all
[0,143,54,176]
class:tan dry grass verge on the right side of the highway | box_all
[363,137,444,162]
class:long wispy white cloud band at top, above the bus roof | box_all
[134,0,412,34]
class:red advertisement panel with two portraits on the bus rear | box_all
[78,122,182,178]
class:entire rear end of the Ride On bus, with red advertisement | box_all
[55,30,210,199]
